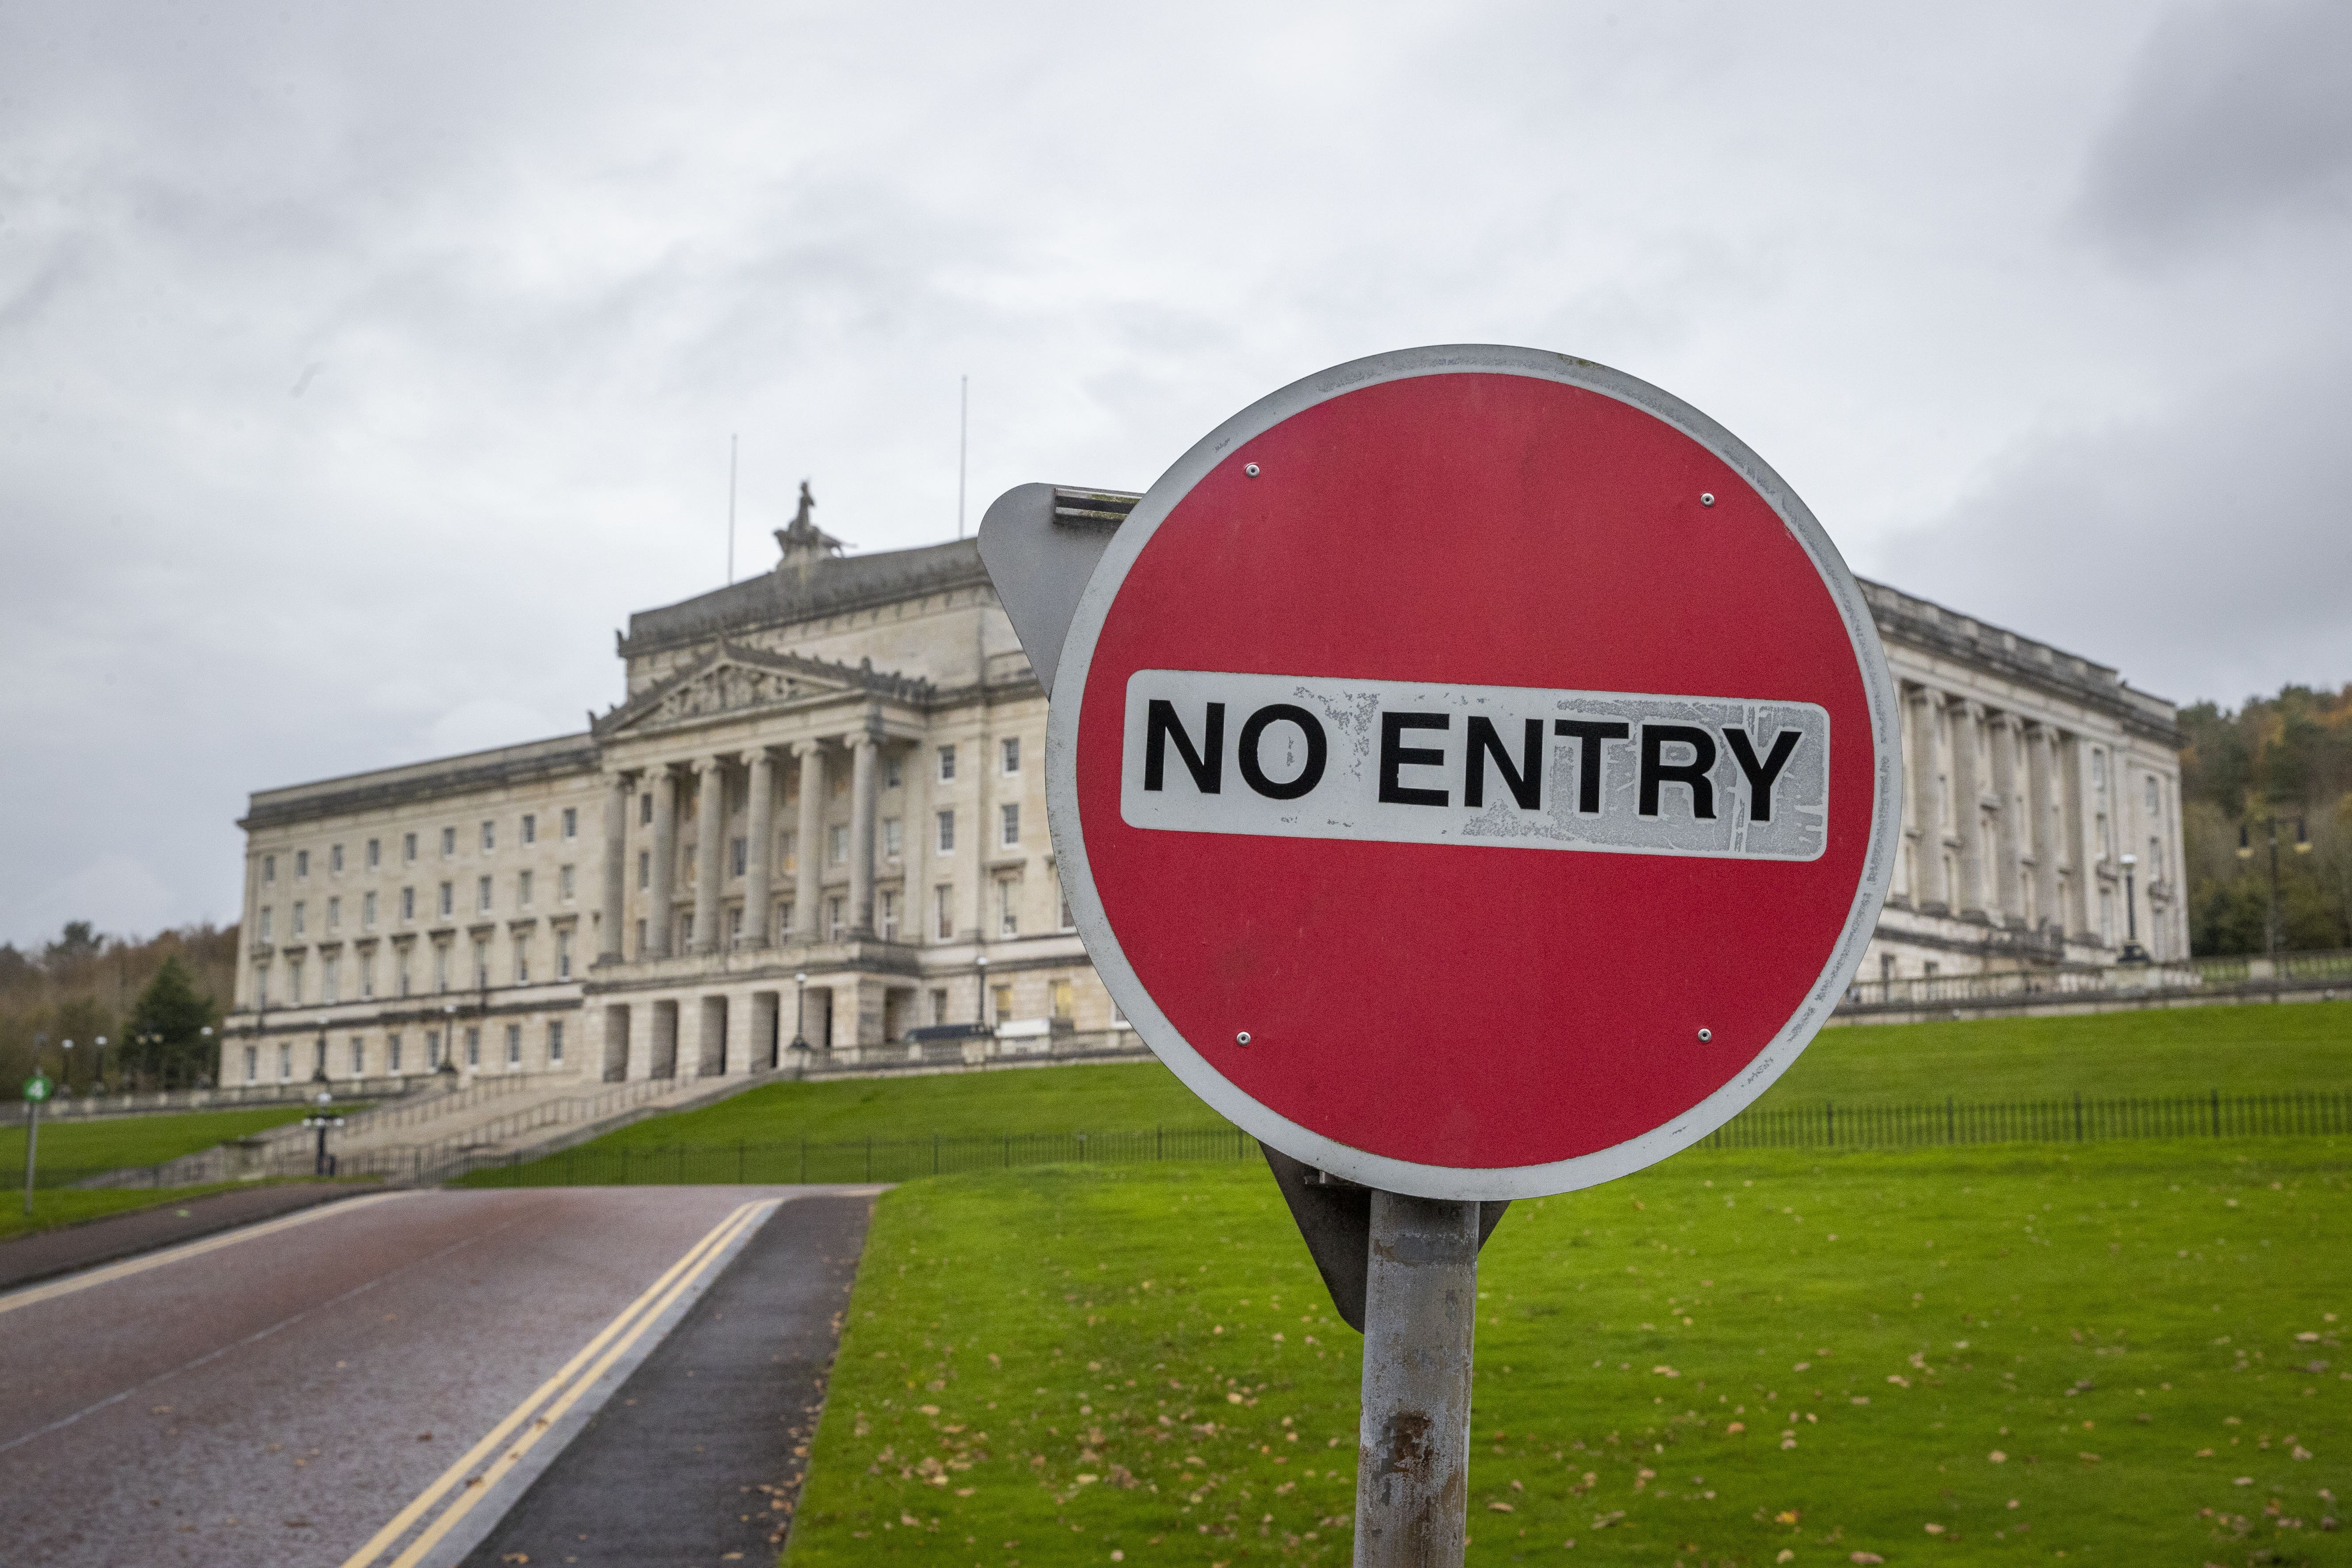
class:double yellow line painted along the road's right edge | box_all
[343,1199,776,1568]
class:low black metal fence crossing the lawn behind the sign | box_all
[449,1091,2352,1187]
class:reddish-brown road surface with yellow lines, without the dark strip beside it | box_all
[0,1187,866,1568]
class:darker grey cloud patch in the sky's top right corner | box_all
[2079,0,2352,261]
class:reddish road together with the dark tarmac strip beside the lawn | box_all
[0,1187,868,1568]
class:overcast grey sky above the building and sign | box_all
[0,0,2352,943]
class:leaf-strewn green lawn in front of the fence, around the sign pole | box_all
[788,1140,2352,1568]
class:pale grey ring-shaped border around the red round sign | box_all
[1044,343,1903,1201]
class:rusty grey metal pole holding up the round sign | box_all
[1355,1192,1479,1568]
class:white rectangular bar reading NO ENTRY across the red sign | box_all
[1120,670,1830,860]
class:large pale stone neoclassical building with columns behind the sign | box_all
[221,496,2187,1081]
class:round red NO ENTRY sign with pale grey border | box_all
[1047,348,1900,1199]
